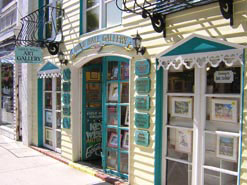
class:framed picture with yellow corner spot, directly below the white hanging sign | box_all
[211,99,238,123]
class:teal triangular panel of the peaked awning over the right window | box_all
[163,37,235,57]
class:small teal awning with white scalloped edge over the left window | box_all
[38,62,61,78]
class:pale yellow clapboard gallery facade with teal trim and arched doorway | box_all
[19,0,247,185]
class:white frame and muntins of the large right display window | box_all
[162,64,243,185]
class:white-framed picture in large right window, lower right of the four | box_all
[216,135,237,162]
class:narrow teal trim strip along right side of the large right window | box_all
[237,49,245,185]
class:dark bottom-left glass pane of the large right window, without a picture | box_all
[166,160,192,185]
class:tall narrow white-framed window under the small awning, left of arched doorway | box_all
[43,77,61,152]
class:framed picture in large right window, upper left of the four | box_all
[171,97,192,118]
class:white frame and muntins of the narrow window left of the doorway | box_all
[42,77,62,153]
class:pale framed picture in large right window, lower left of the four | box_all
[175,129,192,154]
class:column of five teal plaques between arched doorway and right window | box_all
[135,60,151,147]
